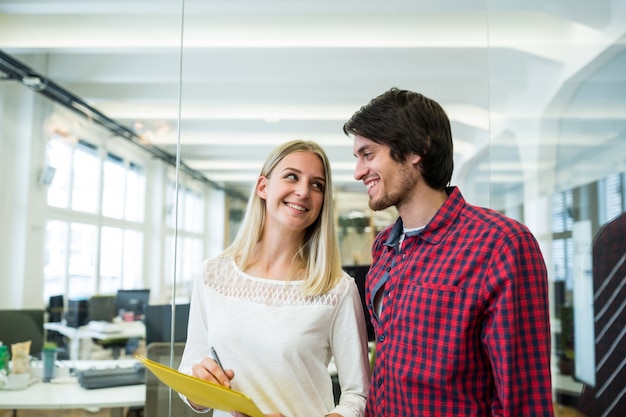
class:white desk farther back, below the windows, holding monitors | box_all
[44,321,146,360]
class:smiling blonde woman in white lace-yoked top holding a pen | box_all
[180,140,369,417]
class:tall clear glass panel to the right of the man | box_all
[486,2,626,415]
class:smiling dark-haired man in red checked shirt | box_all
[343,88,553,417]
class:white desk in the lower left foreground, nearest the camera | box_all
[0,360,146,416]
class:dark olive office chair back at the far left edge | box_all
[0,309,44,356]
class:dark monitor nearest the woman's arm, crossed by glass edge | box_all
[144,304,189,346]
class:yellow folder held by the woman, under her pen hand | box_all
[137,356,264,417]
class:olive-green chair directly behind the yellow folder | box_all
[144,342,204,417]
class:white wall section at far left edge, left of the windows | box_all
[0,78,46,308]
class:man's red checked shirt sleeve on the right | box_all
[482,232,552,416]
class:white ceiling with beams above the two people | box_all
[0,0,626,208]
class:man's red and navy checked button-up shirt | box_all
[366,187,553,417]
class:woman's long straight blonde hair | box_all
[222,140,342,296]
